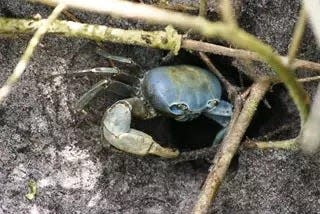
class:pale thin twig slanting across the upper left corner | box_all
[0,4,66,104]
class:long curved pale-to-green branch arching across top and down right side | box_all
[32,0,310,124]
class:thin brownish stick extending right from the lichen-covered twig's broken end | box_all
[181,39,320,72]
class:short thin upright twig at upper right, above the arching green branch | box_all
[288,5,307,65]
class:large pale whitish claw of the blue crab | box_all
[102,100,179,158]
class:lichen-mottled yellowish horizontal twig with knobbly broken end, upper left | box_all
[0,18,181,54]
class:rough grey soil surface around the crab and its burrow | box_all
[0,0,320,214]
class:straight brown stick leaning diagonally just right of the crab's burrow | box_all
[193,81,270,214]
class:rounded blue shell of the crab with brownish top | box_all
[142,65,221,121]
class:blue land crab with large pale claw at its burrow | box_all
[79,65,232,158]
